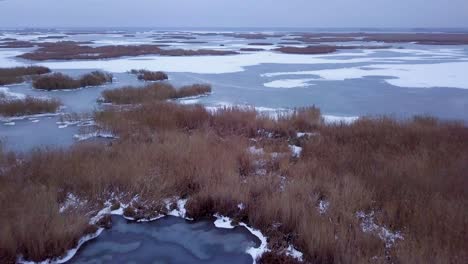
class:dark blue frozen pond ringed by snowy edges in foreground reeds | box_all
[69,216,259,264]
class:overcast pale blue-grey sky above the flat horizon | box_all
[0,0,468,27]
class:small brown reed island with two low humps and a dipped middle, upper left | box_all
[33,71,113,91]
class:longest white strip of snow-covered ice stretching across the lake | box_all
[37,50,402,74]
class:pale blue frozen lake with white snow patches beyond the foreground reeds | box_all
[0,31,468,150]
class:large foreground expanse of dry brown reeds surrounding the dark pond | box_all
[0,102,468,263]
